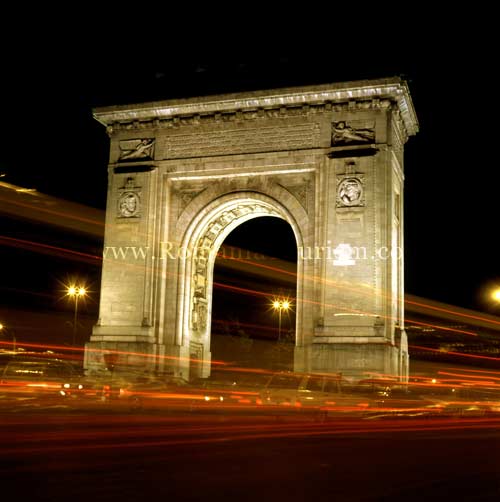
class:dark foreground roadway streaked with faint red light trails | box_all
[0,407,500,501]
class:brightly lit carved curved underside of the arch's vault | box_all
[177,191,307,374]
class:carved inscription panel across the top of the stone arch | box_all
[157,124,320,159]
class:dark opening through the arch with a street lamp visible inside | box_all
[211,217,297,376]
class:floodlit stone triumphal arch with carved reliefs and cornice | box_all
[85,78,418,378]
